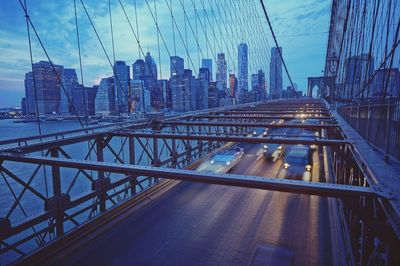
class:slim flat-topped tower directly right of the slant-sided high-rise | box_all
[114,61,130,113]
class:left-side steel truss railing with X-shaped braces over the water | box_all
[0,128,228,264]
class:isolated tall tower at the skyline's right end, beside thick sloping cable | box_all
[269,47,282,99]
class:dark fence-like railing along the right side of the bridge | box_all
[337,99,400,161]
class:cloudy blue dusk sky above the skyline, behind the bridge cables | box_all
[0,0,331,107]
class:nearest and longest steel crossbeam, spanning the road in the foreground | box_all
[0,154,380,198]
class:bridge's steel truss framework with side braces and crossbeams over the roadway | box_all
[0,100,399,262]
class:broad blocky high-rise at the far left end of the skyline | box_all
[25,61,64,115]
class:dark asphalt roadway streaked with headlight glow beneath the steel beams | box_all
[66,130,333,265]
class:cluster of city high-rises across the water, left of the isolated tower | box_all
[21,43,267,116]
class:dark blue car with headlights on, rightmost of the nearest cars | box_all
[283,145,312,178]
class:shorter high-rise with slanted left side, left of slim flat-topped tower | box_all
[94,77,117,115]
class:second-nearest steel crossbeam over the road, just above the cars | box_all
[110,131,349,146]
